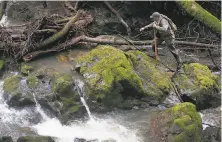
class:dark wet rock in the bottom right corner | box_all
[201,127,221,142]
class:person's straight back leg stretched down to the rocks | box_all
[164,38,182,70]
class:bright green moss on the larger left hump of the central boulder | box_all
[77,45,144,97]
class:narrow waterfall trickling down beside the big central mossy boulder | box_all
[74,79,93,120]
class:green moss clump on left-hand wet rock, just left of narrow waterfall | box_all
[52,74,72,95]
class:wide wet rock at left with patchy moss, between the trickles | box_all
[3,68,86,123]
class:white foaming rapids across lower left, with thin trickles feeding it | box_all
[0,80,141,142]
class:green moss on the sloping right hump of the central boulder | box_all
[126,51,171,95]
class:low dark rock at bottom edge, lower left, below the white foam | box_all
[17,136,55,142]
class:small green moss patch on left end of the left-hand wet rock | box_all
[3,75,22,93]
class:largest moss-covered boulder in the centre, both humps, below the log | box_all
[76,45,171,108]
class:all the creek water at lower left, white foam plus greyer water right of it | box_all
[0,76,153,142]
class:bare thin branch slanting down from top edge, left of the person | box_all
[104,1,131,36]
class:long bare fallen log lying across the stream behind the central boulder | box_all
[23,35,220,61]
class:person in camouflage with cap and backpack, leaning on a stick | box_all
[140,12,181,74]
